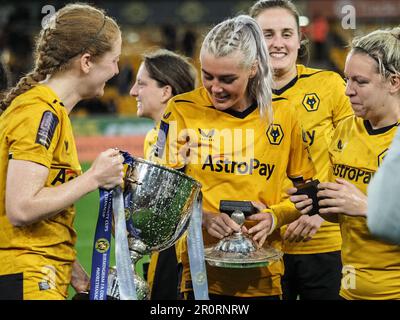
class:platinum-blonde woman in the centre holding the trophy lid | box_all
[155,15,314,300]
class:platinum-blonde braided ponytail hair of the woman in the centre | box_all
[201,15,273,124]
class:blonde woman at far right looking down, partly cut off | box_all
[289,28,400,300]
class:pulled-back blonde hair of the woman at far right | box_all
[351,27,400,79]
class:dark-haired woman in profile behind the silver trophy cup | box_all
[130,49,197,300]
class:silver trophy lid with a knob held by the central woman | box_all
[204,210,283,268]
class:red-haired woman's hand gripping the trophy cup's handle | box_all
[89,149,124,189]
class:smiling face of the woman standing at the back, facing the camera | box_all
[255,8,300,77]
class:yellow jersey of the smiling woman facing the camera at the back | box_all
[273,65,353,254]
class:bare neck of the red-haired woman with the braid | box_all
[44,75,82,113]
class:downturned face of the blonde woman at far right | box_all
[344,52,389,120]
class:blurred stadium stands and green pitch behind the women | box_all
[0,0,400,295]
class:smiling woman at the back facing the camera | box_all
[250,0,352,300]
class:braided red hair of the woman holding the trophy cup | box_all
[0,4,120,114]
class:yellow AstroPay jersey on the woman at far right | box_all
[329,117,400,299]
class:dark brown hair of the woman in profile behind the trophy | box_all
[143,49,197,96]
